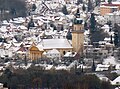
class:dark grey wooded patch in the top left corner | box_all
[0,0,27,20]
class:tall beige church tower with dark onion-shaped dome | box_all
[72,9,84,54]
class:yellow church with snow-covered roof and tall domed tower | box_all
[29,9,84,60]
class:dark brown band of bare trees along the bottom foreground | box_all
[0,66,112,89]
